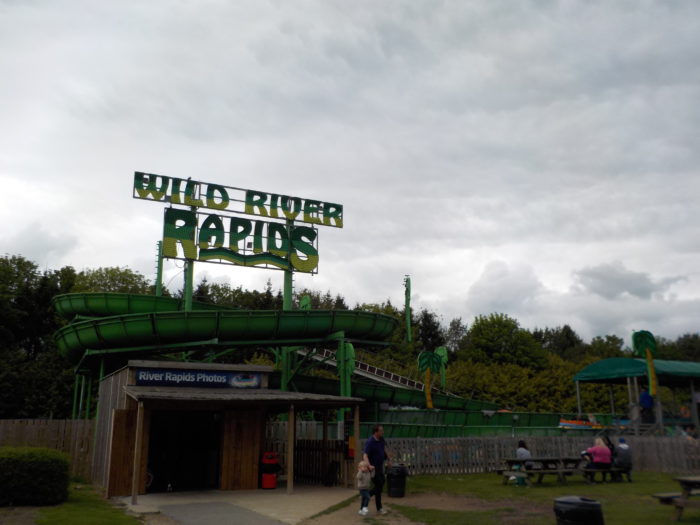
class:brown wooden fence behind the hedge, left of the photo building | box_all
[0,419,93,480]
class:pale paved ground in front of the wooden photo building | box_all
[120,486,357,525]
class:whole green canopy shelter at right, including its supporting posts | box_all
[574,357,700,432]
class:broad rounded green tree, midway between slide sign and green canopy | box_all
[460,313,546,369]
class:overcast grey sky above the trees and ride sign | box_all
[0,0,700,343]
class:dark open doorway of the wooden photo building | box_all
[147,411,221,492]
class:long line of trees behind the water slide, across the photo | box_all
[0,255,700,418]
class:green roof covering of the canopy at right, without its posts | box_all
[574,357,700,386]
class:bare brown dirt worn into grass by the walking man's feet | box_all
[301,493,552,525]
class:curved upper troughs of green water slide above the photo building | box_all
[54,293,398,363]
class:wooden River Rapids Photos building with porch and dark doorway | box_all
[92,361,362,502]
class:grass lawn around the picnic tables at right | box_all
[387,472,700,525]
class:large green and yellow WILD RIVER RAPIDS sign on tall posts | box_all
[133,171,343,273]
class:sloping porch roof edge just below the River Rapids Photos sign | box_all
[124,385,364,408]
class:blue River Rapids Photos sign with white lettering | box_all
[136,368,261,388]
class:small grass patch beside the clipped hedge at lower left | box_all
[36,485,143,525]
